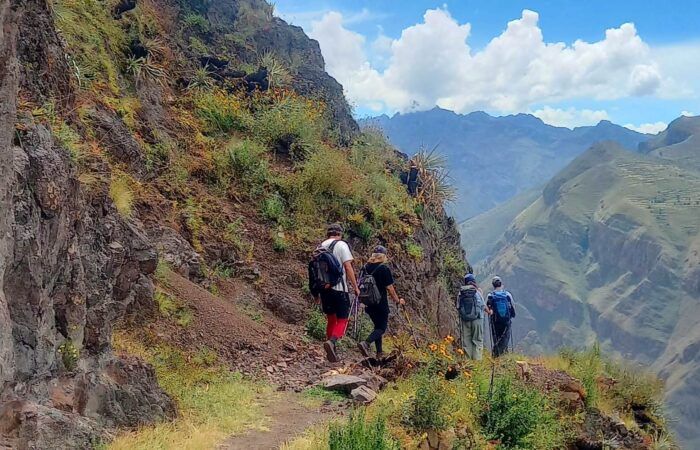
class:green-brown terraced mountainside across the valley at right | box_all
[479,118,700,448]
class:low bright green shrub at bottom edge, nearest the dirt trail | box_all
[328,409,399,450]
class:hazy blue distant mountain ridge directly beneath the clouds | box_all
[361,108,648,220]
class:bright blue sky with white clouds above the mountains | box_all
[275,0,700,131]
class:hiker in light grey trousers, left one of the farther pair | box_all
[457,273,486,360]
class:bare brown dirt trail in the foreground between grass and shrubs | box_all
[217,392,339,450]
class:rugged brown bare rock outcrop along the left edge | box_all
[0,0,174,448]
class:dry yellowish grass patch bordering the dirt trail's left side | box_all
[107,333,272,450]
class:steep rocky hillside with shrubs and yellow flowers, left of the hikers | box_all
[0,0,466,448]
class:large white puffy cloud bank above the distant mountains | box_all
[310,7,671,114]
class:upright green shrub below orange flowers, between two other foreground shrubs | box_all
[402,371,450,432]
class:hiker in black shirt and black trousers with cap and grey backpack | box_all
[358,245,406,358]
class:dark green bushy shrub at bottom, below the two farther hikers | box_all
[480,374,566,450]
